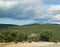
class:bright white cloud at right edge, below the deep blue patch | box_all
[47,5,60,21]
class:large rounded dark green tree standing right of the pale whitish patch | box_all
[40,30,53,41]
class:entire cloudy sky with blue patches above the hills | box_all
[0,0,60,25]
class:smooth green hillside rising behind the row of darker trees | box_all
[0,24,60,41]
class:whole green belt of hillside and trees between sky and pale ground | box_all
[0,24,60,42]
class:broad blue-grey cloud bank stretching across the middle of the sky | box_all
[0,0,60,23]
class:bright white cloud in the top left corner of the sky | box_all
[0,1,17,8]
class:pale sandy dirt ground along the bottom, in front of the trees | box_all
[5,42,60,47]
